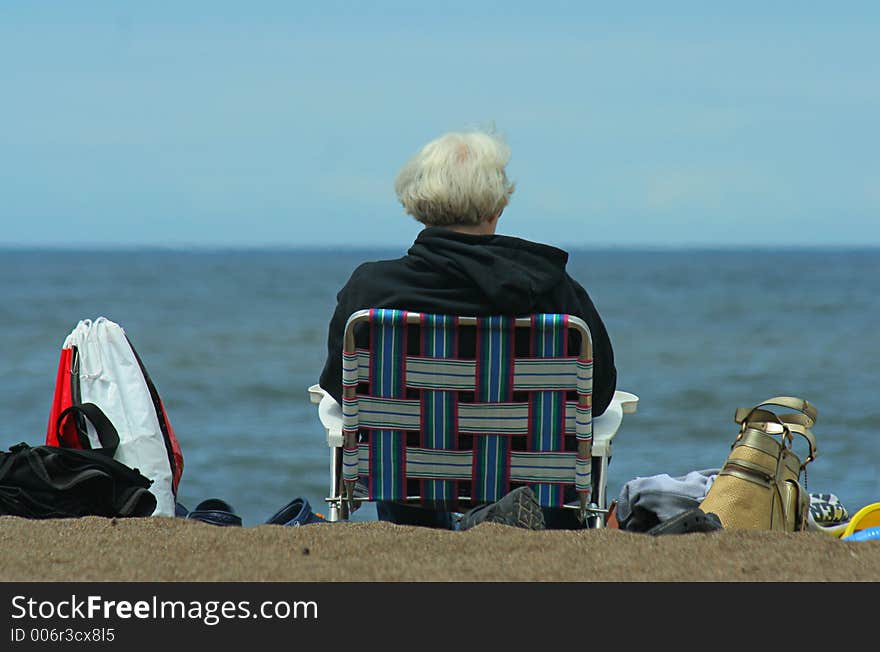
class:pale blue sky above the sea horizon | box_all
[0,0,880,247]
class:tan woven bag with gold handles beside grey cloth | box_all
[700,396,817,532]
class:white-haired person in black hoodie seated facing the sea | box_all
[320,132,616,524]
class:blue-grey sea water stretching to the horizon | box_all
[0,248,880,526]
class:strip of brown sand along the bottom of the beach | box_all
[0,516,880,582]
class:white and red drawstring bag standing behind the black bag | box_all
[46,317,183,516]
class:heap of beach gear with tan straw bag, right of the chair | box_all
[609,396,880,541]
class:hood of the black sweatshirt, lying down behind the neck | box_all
[408,227,568,314]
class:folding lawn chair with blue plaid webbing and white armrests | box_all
[309,309,639,527]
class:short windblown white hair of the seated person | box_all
[394,131,514,226]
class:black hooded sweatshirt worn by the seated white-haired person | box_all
[320,227,617,416]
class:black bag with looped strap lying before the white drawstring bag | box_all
[0,403,156,518]
